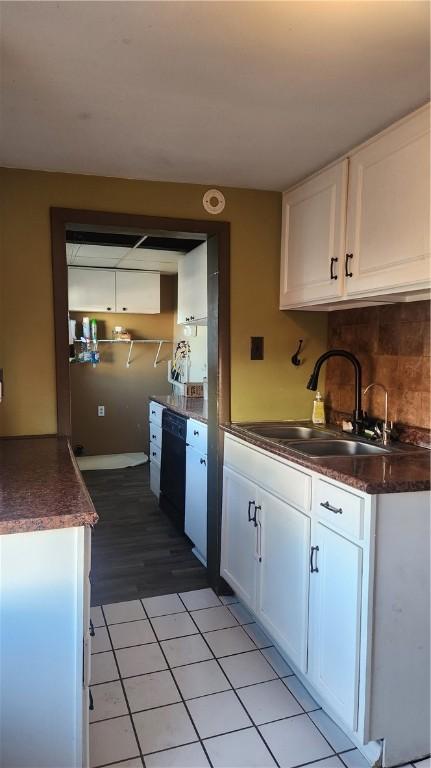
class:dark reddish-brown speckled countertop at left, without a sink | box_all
[0,436,98,534]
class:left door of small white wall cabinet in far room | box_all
[68,267,115,312]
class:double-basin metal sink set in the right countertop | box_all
[238,422,392,459]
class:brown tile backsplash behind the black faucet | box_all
[326,301,431,428]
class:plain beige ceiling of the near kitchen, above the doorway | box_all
[0,0,429,189]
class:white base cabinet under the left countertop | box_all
[0,526,90,768]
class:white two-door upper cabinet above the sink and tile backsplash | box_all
[280,105,431,309]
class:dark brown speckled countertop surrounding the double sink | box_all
[221,424,431,494]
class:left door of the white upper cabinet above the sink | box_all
[280,160,347,309]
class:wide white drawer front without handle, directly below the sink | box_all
[224,436,311,512]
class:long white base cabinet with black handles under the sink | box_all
[221,434,431,768]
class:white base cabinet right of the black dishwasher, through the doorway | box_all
[184,419,208,565]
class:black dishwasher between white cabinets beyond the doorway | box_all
[159,408,187,532]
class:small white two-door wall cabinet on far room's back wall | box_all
[68,267,160,315]
